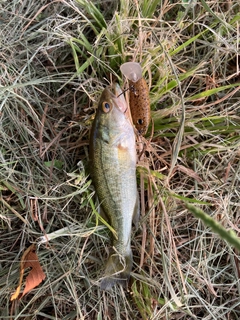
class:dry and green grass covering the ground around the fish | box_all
[0,0,240,320]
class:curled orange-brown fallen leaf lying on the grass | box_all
[11,244,46,301]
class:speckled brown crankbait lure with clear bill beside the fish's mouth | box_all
[120,62,150,135]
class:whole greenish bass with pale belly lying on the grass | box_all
[90,84,139,290]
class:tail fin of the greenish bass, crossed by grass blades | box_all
[101,250,133,291]
